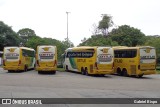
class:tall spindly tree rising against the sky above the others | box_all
[98,15,114,36]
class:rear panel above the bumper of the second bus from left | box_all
[38,46,56,67]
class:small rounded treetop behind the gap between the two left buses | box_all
[17,28,36,45]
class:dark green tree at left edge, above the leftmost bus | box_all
[0,21,21,51]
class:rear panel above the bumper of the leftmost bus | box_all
[3,47,21,66]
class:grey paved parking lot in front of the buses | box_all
[0,68,160,107]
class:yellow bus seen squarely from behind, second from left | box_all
[36,45,57,74]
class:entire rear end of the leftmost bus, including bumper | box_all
[3,47,21,72]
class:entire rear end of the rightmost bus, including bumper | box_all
[138,46,156,76]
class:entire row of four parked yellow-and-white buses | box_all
[3,45,156,77]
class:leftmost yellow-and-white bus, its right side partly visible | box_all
[3,47,35,72]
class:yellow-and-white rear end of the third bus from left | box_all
[95,47,114,75]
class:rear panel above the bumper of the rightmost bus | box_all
[140,47,156,70]
